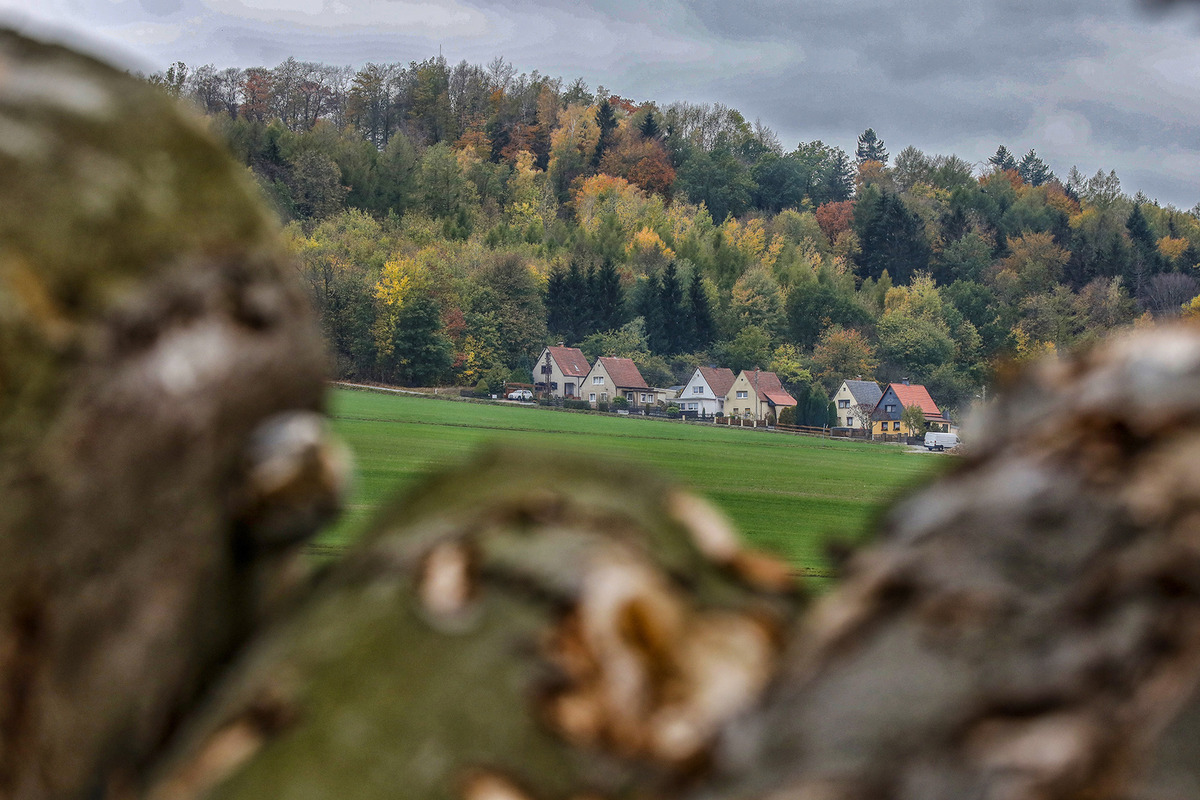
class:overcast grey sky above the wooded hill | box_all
[0,0,1200,209]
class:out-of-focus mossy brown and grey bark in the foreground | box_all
[7,25,1200,800]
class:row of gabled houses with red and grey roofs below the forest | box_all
[533,345,950,434]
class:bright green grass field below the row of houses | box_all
[317,389,950,575]
